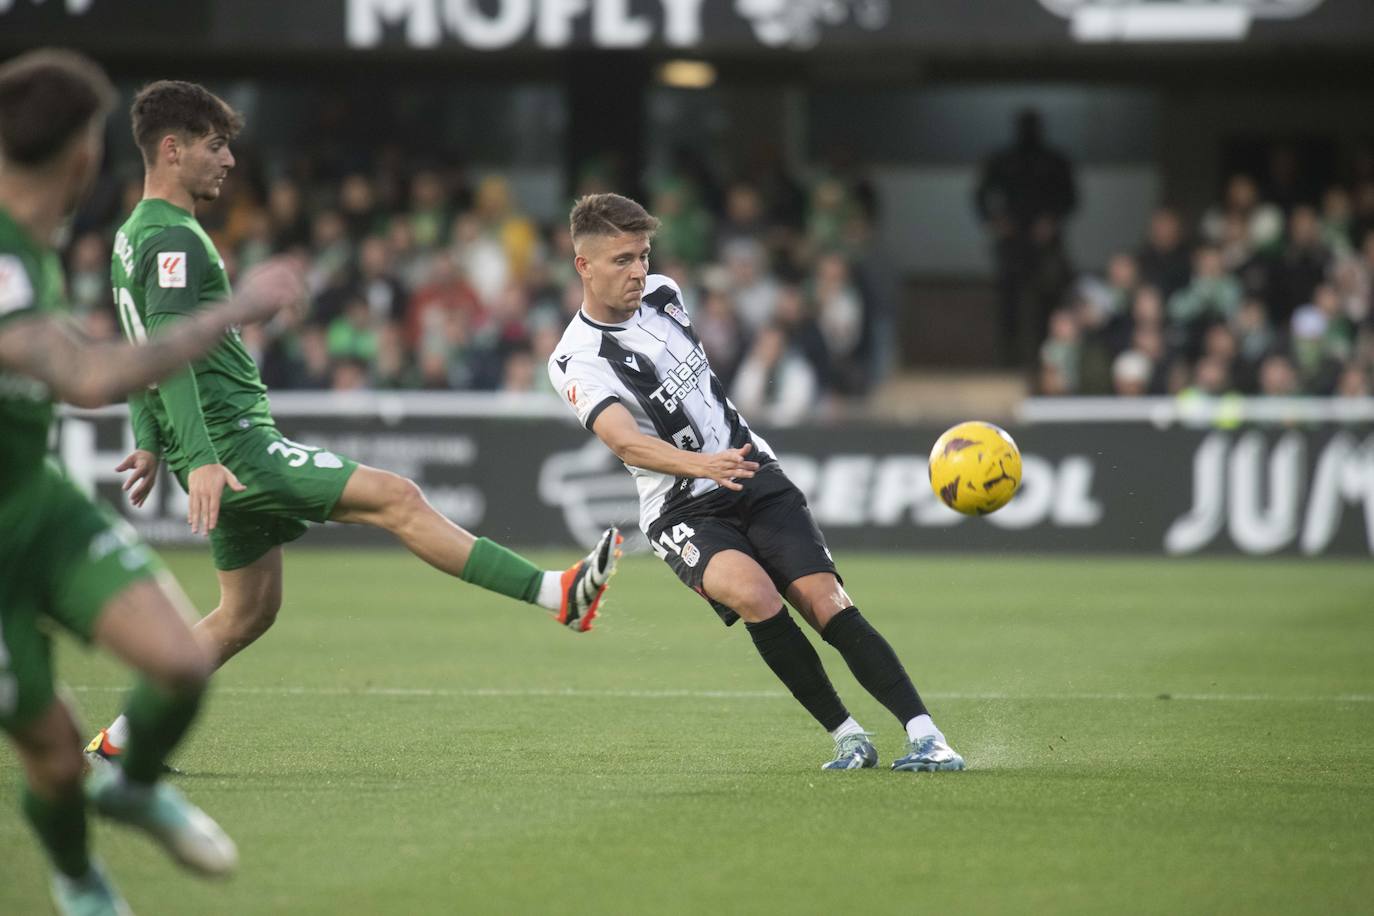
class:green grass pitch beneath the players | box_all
[0,549,1374,915]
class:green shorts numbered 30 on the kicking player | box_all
[177,426,357,570]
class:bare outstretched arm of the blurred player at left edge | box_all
[0,260,305,407]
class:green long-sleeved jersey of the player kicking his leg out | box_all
[110,199,272,471]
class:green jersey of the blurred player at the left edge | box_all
[0,209,67,504]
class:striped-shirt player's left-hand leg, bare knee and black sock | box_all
[701,551,878,769]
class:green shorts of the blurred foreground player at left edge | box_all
[0,461,162,731]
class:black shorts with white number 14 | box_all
[649,463,844,626]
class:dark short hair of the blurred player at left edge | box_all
[0,48,115,166]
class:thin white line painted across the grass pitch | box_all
[61,685,1374,703]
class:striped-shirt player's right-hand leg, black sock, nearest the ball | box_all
[787,573,963,769]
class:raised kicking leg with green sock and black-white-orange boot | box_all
[330,466,620,630]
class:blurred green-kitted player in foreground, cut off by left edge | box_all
[0,51,305,915]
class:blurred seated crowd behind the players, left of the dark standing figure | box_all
[67,149,883,423]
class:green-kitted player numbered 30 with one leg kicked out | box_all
[87,80,621,759]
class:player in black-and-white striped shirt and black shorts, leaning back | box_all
[548,194,963,770]
